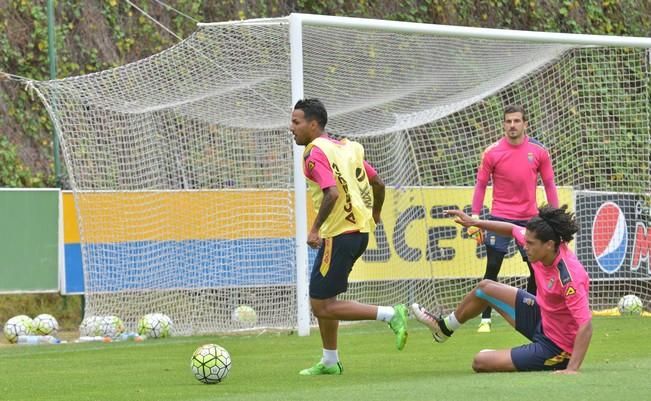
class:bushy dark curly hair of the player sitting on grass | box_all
[527,205,579,249]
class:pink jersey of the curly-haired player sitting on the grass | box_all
[512,226,592,354]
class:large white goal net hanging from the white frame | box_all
[33,17,651,334]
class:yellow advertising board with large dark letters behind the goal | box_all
[350,187,574,281]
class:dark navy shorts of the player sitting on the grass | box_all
[511,290,571,371]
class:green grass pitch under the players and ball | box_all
[0,317,651,401]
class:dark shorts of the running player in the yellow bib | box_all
[310,232,368,299]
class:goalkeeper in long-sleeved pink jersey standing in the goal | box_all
[468,105,558,333]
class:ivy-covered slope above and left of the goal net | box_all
[0,0,651,187]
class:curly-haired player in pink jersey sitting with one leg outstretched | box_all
[412,206,592,374]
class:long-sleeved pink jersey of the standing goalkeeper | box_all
[472,136,558,220]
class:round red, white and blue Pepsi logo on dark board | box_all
[592,202,628,273]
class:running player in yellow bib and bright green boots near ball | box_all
[291,99,408,375]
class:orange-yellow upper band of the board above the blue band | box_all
[63,190,294,243]
